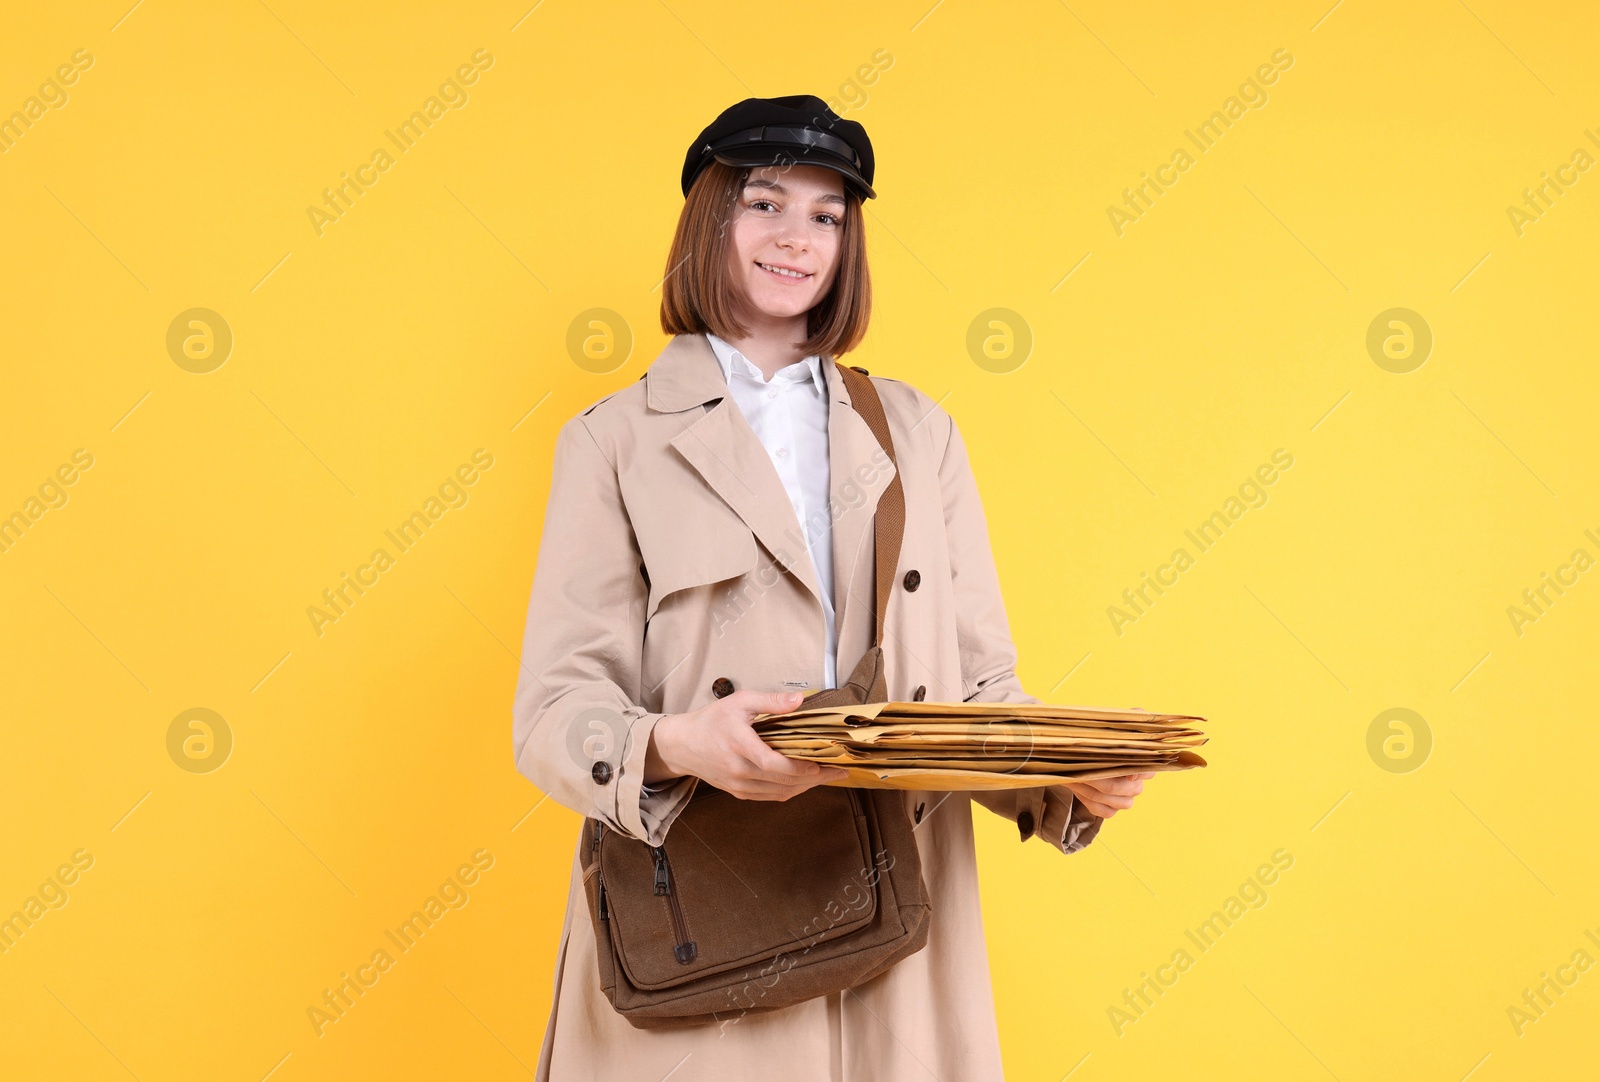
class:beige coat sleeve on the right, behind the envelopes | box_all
[939,410,1104,853]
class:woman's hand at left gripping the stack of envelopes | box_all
[645,691,846,800]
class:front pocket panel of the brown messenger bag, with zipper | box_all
[600,781,880,991]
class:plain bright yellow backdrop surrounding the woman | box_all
[0,0,1600,1082]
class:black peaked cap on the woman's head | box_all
[683,94,877,198]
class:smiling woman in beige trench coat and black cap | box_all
[514,96,1150,1082]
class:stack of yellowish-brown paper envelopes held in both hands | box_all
[755,703,1206,789]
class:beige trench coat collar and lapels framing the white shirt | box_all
[645,335,896,658]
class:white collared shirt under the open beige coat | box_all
[706,333,838,688]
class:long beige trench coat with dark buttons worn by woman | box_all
[512,335,1101,1082]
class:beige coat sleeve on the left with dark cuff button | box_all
[512,416,694,845]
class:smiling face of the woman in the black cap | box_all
[728,165,848,319]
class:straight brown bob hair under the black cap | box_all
[661,162,872,357]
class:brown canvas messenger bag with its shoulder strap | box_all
[579,365,930,1029]
